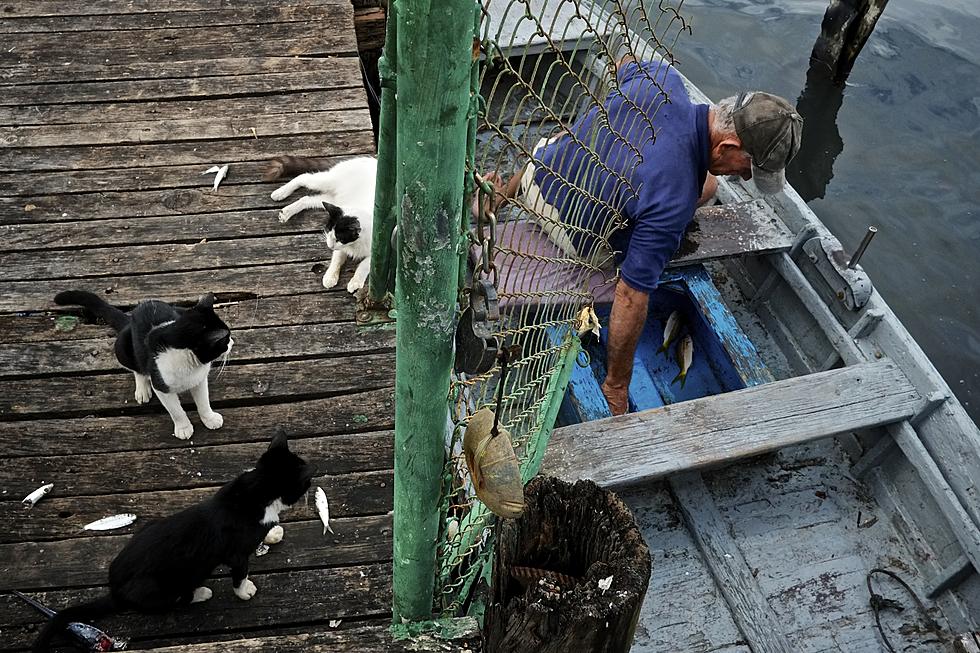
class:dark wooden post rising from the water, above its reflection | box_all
[810,0,888,84]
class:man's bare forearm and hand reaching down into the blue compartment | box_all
[603,279,649,415]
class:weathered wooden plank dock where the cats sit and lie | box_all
[0,0,468,651]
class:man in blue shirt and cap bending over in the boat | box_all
[474,57,803,415]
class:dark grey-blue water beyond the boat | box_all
[649,0,980,422]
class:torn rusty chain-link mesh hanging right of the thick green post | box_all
[435,0,690,614]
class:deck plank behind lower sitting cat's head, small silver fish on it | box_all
[0,469,394,543]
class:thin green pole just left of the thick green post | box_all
[368,0,398,305]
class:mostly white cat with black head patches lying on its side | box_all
[266,156,378,293]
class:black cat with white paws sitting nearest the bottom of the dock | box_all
[34,433,315,653]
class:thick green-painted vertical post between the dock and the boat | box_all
[392,0,476,624]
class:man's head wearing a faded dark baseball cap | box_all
[708,91,803,195]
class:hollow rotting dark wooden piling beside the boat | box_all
[484,477,650,653]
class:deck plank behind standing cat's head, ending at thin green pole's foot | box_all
[0,292,354,346]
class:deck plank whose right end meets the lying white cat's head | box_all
[0,208,322,251]
